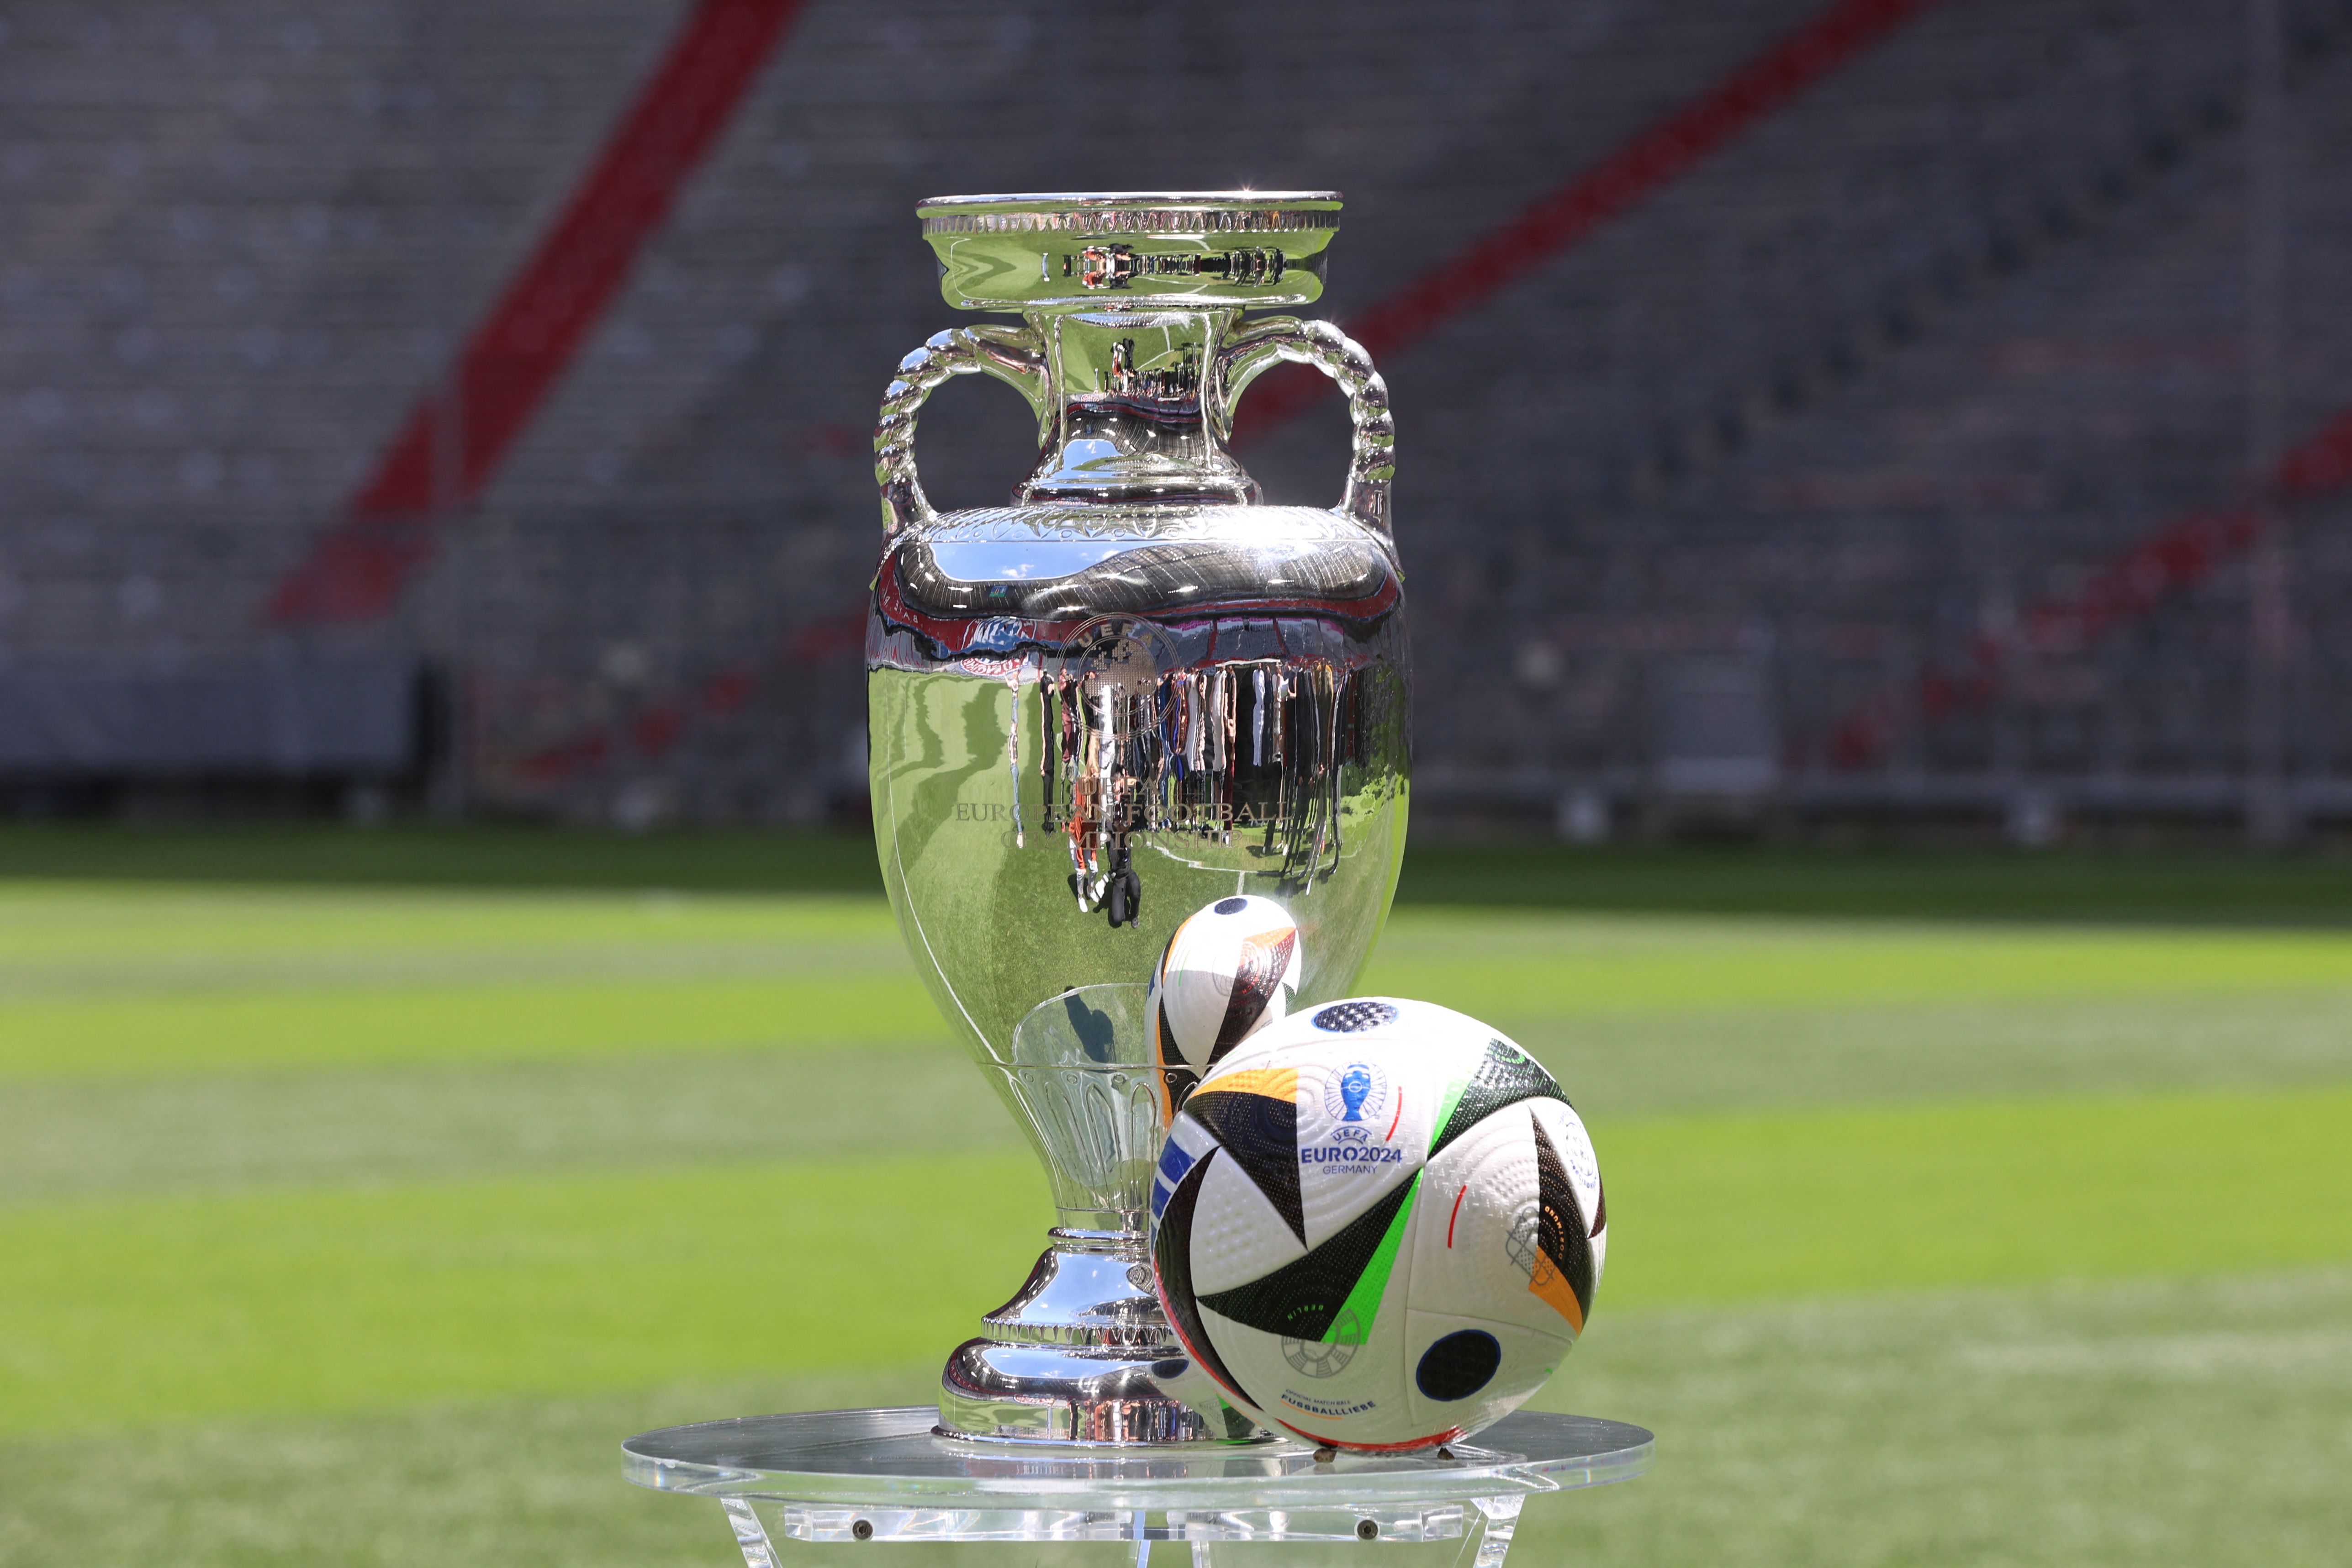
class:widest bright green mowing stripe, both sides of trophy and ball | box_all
[0,1091,2352,1431]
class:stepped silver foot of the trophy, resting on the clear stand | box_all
[938,1230,1268,1446]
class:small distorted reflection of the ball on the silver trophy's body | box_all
[1150,893,1303,1126]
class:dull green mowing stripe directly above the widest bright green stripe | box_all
[18,994,2352,1206]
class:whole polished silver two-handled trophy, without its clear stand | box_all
[866,190,1409,1443]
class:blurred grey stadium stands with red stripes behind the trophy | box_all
[0,0,2352,839]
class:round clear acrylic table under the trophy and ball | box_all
[621,1406,1651,1568]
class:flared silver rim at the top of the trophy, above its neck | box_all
[915,190,1341,310]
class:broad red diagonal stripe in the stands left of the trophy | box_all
[264,0,802,625]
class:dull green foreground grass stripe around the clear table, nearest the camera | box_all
[18,1272,2352,1568]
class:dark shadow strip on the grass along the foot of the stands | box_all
[0,823,2352,926]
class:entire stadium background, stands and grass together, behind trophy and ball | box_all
[0,0,2352,1568]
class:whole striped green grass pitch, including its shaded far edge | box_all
[0,830,2352,1568]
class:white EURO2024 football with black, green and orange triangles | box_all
[1152,997,1609,1451]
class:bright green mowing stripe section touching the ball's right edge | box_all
[1595,1088,2352,1312]
